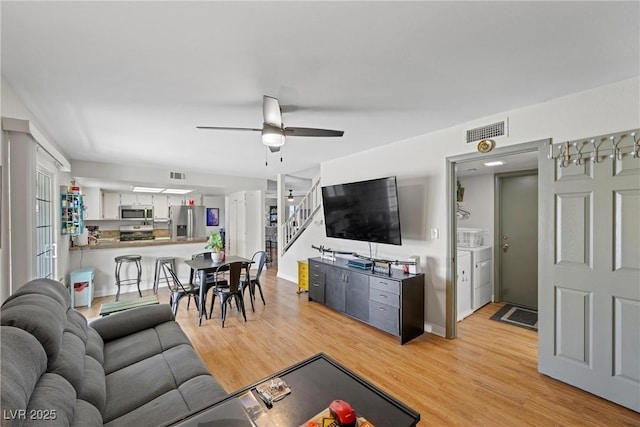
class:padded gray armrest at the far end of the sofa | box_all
[89,304,174,341]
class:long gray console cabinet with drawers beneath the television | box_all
[309,258,424,344]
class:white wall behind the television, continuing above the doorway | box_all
[278,76,640,334]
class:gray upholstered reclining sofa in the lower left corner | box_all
[0,279,227,427]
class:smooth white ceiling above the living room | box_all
[1,1,640,186]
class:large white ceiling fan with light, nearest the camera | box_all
[196,95,344,153]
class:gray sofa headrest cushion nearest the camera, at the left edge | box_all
[0,326,47,411]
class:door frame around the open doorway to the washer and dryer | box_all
[445,138,551,338]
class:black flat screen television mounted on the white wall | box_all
[322,176,402,245]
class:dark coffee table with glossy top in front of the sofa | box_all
[176,353,420,427]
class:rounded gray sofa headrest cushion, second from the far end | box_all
[0,294,67,362]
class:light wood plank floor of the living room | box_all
[79,262,640,426]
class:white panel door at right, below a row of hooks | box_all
[538,131,640,411]
